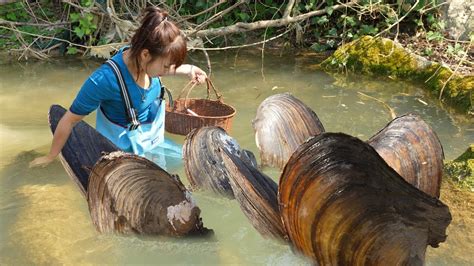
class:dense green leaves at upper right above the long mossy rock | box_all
[300,0,444,51]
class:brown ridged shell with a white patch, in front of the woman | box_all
[88,152,207,236]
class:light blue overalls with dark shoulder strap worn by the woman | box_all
[96,59,182,170]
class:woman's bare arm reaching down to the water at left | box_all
[30,110,84,167]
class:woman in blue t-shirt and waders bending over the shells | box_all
[30,7,207,166]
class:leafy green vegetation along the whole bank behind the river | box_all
[0,0,460,57]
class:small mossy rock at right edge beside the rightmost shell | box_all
[444,144,474,192]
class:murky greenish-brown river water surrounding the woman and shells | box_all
[0,51,474,265]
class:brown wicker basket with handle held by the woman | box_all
[165,79,236,136]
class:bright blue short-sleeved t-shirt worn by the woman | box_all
[69,48,161,126]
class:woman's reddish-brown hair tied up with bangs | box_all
[130,6,187,77]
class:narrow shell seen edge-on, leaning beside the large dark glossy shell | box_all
[222,148,285,240]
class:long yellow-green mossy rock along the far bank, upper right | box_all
[321,36,474,113]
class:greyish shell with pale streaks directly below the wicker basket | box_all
[183,127,256,198]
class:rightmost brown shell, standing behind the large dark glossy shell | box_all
[368,114,444,197]
